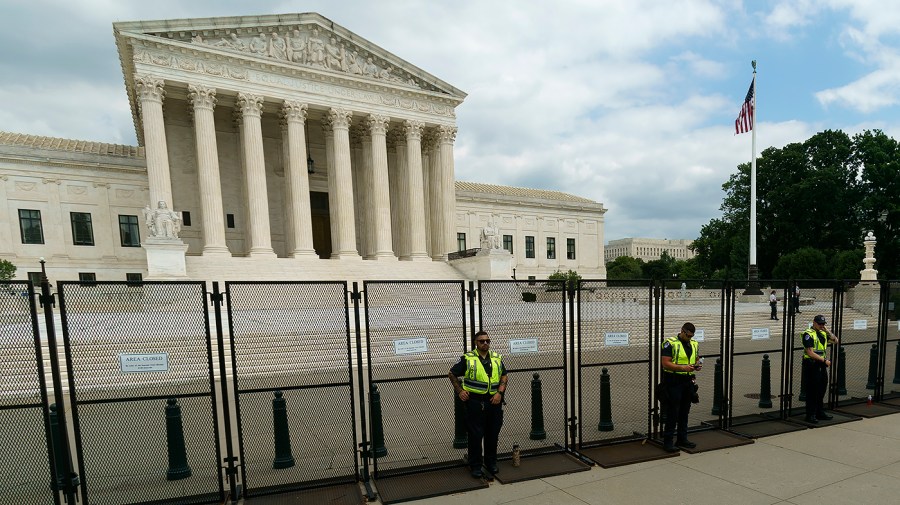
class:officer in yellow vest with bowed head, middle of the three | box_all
[661,323,703,452]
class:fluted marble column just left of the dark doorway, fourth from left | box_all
[281,101,318,258]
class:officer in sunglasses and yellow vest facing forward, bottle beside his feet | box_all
[448,331,507,479]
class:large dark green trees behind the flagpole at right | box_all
[693,130,900,279]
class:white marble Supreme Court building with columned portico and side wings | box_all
[0,13,606,280]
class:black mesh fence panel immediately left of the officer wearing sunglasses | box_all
[363,281,470,478]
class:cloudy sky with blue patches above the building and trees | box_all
[0,0,900,240]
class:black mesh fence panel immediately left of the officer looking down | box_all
[577,281,656,447]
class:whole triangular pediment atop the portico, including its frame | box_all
[113,13,466,101]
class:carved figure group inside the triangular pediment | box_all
[191,25,426,91]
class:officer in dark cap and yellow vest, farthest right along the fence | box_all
[801,314,838,424]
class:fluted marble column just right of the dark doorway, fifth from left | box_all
[328,108,360,259]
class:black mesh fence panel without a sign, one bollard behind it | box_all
[225,282,358,496]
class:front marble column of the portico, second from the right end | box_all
[404,120,429,261]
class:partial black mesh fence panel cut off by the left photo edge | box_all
[0,282,59,505]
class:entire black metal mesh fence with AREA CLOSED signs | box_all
[7,280,900,504]
